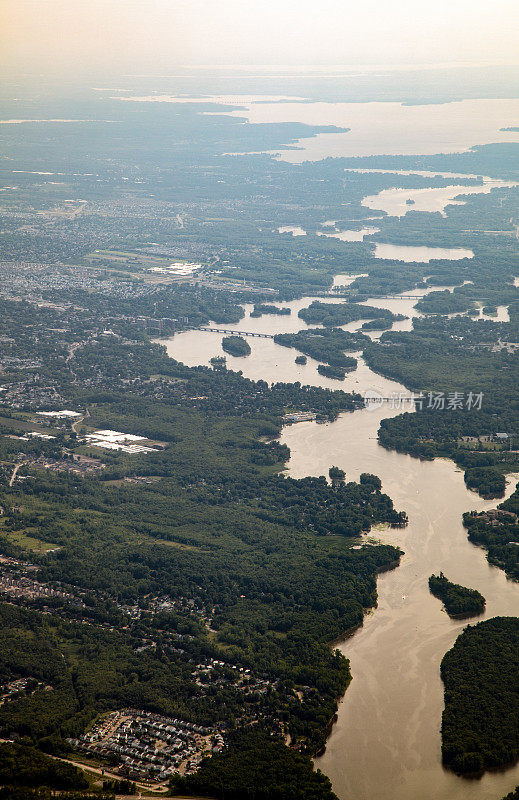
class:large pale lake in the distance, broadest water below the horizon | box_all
[118,94,519,164]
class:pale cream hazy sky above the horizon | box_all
[0,0,519,75]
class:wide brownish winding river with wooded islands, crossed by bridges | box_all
[159,288,519,800]
